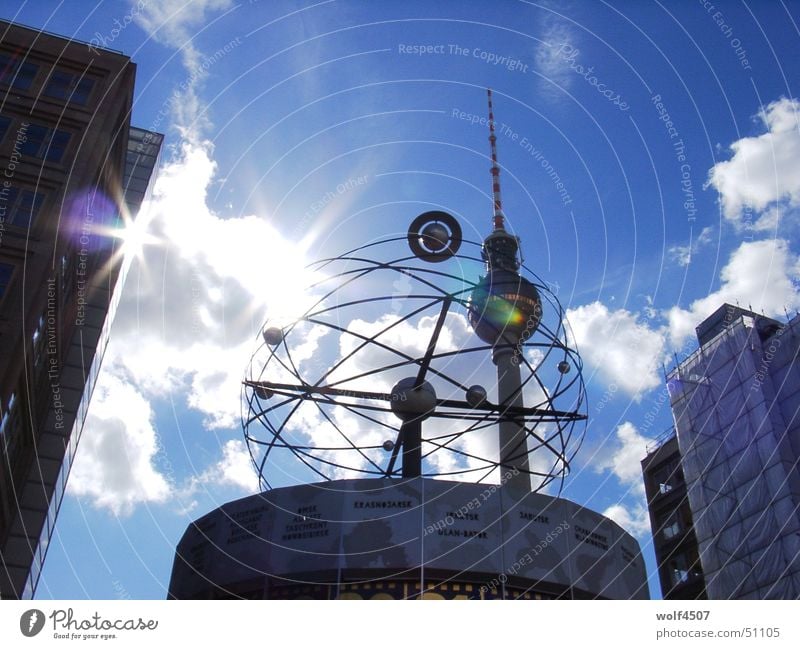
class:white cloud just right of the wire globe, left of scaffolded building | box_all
[567,301,665,398]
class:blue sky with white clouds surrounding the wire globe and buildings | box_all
[3,0,800,598]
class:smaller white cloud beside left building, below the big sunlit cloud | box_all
[69,371,171,515]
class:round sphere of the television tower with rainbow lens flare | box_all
[468,268,542,345]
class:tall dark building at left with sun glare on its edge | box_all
[0,21,163,598]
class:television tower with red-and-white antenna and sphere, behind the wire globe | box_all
[469,89,542,497]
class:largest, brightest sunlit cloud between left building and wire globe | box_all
[103,139,316,429]
